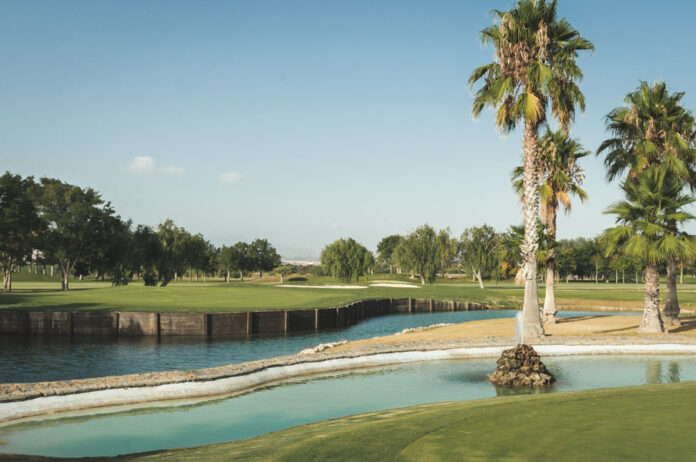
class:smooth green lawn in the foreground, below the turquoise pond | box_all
[85,382,696,462]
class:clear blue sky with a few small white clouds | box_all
[0,0,696,259]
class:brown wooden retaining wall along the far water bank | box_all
[0,298,488,337]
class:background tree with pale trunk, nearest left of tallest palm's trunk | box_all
[459,224,498,289]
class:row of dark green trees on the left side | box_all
[0,172,280,292]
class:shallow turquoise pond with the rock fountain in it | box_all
[0,355,696,457]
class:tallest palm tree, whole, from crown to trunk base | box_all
[469,0,593,340]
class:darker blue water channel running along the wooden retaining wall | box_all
[0,310,632,383]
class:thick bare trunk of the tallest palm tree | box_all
[520,120,544,343]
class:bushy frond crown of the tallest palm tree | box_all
[469,0,594,132]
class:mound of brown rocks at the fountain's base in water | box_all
[490,345,556,388]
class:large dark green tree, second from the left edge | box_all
[39,178,114,290]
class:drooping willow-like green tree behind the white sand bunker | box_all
[402,224,442,284]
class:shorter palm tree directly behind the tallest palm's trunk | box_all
[512,128,590,324]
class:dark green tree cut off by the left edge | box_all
[0,172,45,292]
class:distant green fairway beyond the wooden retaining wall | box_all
[0,275,696,312]
